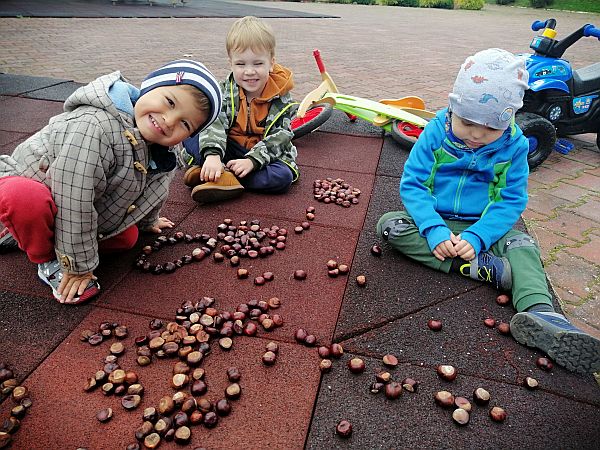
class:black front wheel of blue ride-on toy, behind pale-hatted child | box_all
[515,113,556,170]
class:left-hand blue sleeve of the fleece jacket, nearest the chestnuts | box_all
[400,118,450,250]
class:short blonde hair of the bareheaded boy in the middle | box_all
[225,16,275,58]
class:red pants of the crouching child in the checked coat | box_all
[0,176,138,264]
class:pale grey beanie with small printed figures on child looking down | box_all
[448,48,529,130]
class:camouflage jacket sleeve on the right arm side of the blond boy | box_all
[246,94,297,169]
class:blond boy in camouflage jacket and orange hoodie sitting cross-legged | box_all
[184,16,298,203]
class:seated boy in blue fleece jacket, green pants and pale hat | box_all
[377,49,600,372]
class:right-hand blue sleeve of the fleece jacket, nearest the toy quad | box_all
[462,136,529,253]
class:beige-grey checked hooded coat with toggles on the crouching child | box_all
[0,72,174,273]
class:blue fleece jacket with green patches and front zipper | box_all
[400,109,529,254]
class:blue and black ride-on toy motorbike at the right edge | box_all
[516,19,600,169]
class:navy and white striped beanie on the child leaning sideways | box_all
[140,59,223,136]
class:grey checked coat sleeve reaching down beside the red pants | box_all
[46,115,112,274]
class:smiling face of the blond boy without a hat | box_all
[229,49,275,100]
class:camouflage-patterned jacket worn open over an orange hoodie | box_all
[198,69,299,180]
